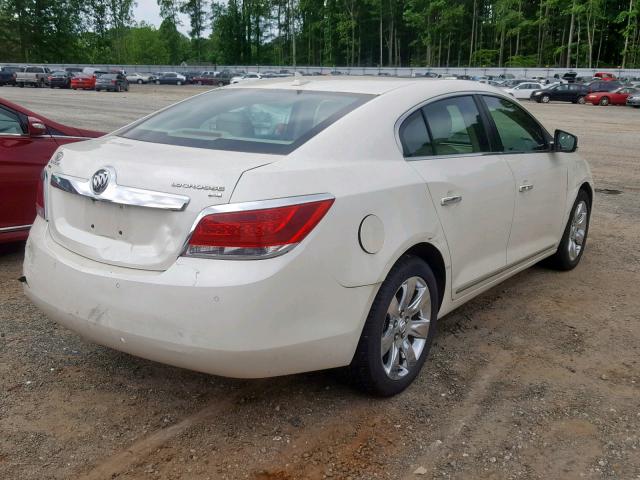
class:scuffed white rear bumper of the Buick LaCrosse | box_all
[24,218,376,378]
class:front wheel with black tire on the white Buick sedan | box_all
[549,190,591,270]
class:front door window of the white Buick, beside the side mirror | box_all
[483,96,548,152]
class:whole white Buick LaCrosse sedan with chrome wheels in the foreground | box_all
[24,77,593,395]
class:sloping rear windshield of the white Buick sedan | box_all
[119,88,373,155]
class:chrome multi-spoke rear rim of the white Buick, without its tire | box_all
[380,277,431,380]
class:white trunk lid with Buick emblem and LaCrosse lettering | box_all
[47,136,278,270]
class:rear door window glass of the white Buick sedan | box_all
[422,96,489,155]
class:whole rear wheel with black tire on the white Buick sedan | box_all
[348,255,439,397]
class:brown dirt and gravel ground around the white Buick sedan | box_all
[0,86,640,480]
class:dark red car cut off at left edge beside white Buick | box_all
[0,98,104,243]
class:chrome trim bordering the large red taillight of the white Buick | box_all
[179,193,336,260]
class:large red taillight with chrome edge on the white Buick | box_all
[184,195,334,259]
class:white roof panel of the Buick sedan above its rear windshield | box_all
[225,76,496,95]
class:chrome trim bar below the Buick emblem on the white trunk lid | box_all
[51,171,191,212]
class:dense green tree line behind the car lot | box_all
[0,0,640,68]
